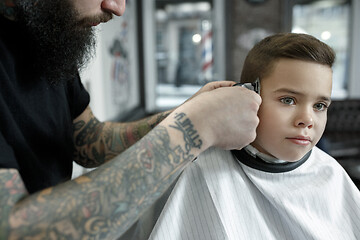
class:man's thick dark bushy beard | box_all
[16,0,111,83]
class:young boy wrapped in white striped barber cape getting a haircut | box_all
[150,33,360,240]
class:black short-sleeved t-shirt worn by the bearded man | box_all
[0,16,89,193]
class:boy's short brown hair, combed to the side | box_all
[240,33,335,83]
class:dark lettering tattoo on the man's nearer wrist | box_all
[170,113,202,154]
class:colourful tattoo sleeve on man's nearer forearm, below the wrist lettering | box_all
[1,123,200,239]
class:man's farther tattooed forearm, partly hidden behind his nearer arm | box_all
[74,106,171,167]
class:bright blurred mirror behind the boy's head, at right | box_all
[292,0,351,98]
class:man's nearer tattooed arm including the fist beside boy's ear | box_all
[0,81,261,239]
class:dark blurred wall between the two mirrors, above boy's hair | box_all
[226,0,285,81]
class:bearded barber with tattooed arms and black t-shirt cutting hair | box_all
[0,0,261,239]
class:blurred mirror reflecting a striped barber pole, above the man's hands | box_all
[143,0,225,112]
